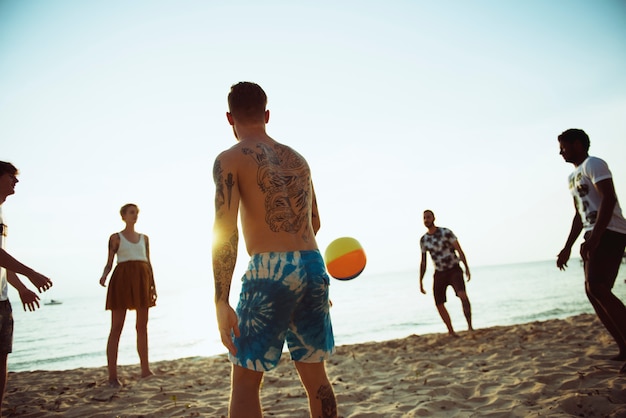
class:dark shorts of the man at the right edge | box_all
[585,229,626,288]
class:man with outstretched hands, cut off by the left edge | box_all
[0,161,52,415]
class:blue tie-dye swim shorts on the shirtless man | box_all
[229,250,335,371]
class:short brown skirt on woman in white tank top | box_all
[106,261,156,309]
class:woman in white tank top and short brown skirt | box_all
[100,203,157,387]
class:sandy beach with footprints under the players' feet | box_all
[3,314,626,418]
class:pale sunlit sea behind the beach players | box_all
[9,260,626,371]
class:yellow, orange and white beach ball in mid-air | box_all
[324,237,366,280]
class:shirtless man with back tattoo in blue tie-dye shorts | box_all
[213,82,337,418]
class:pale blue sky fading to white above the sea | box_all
[0,0,626,298]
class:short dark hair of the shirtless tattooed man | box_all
[228,81,267,122]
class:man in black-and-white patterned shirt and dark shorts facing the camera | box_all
[420,210,474,337]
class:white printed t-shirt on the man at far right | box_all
[569,156,626,234]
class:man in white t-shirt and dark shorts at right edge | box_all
[556,129,626,373]
